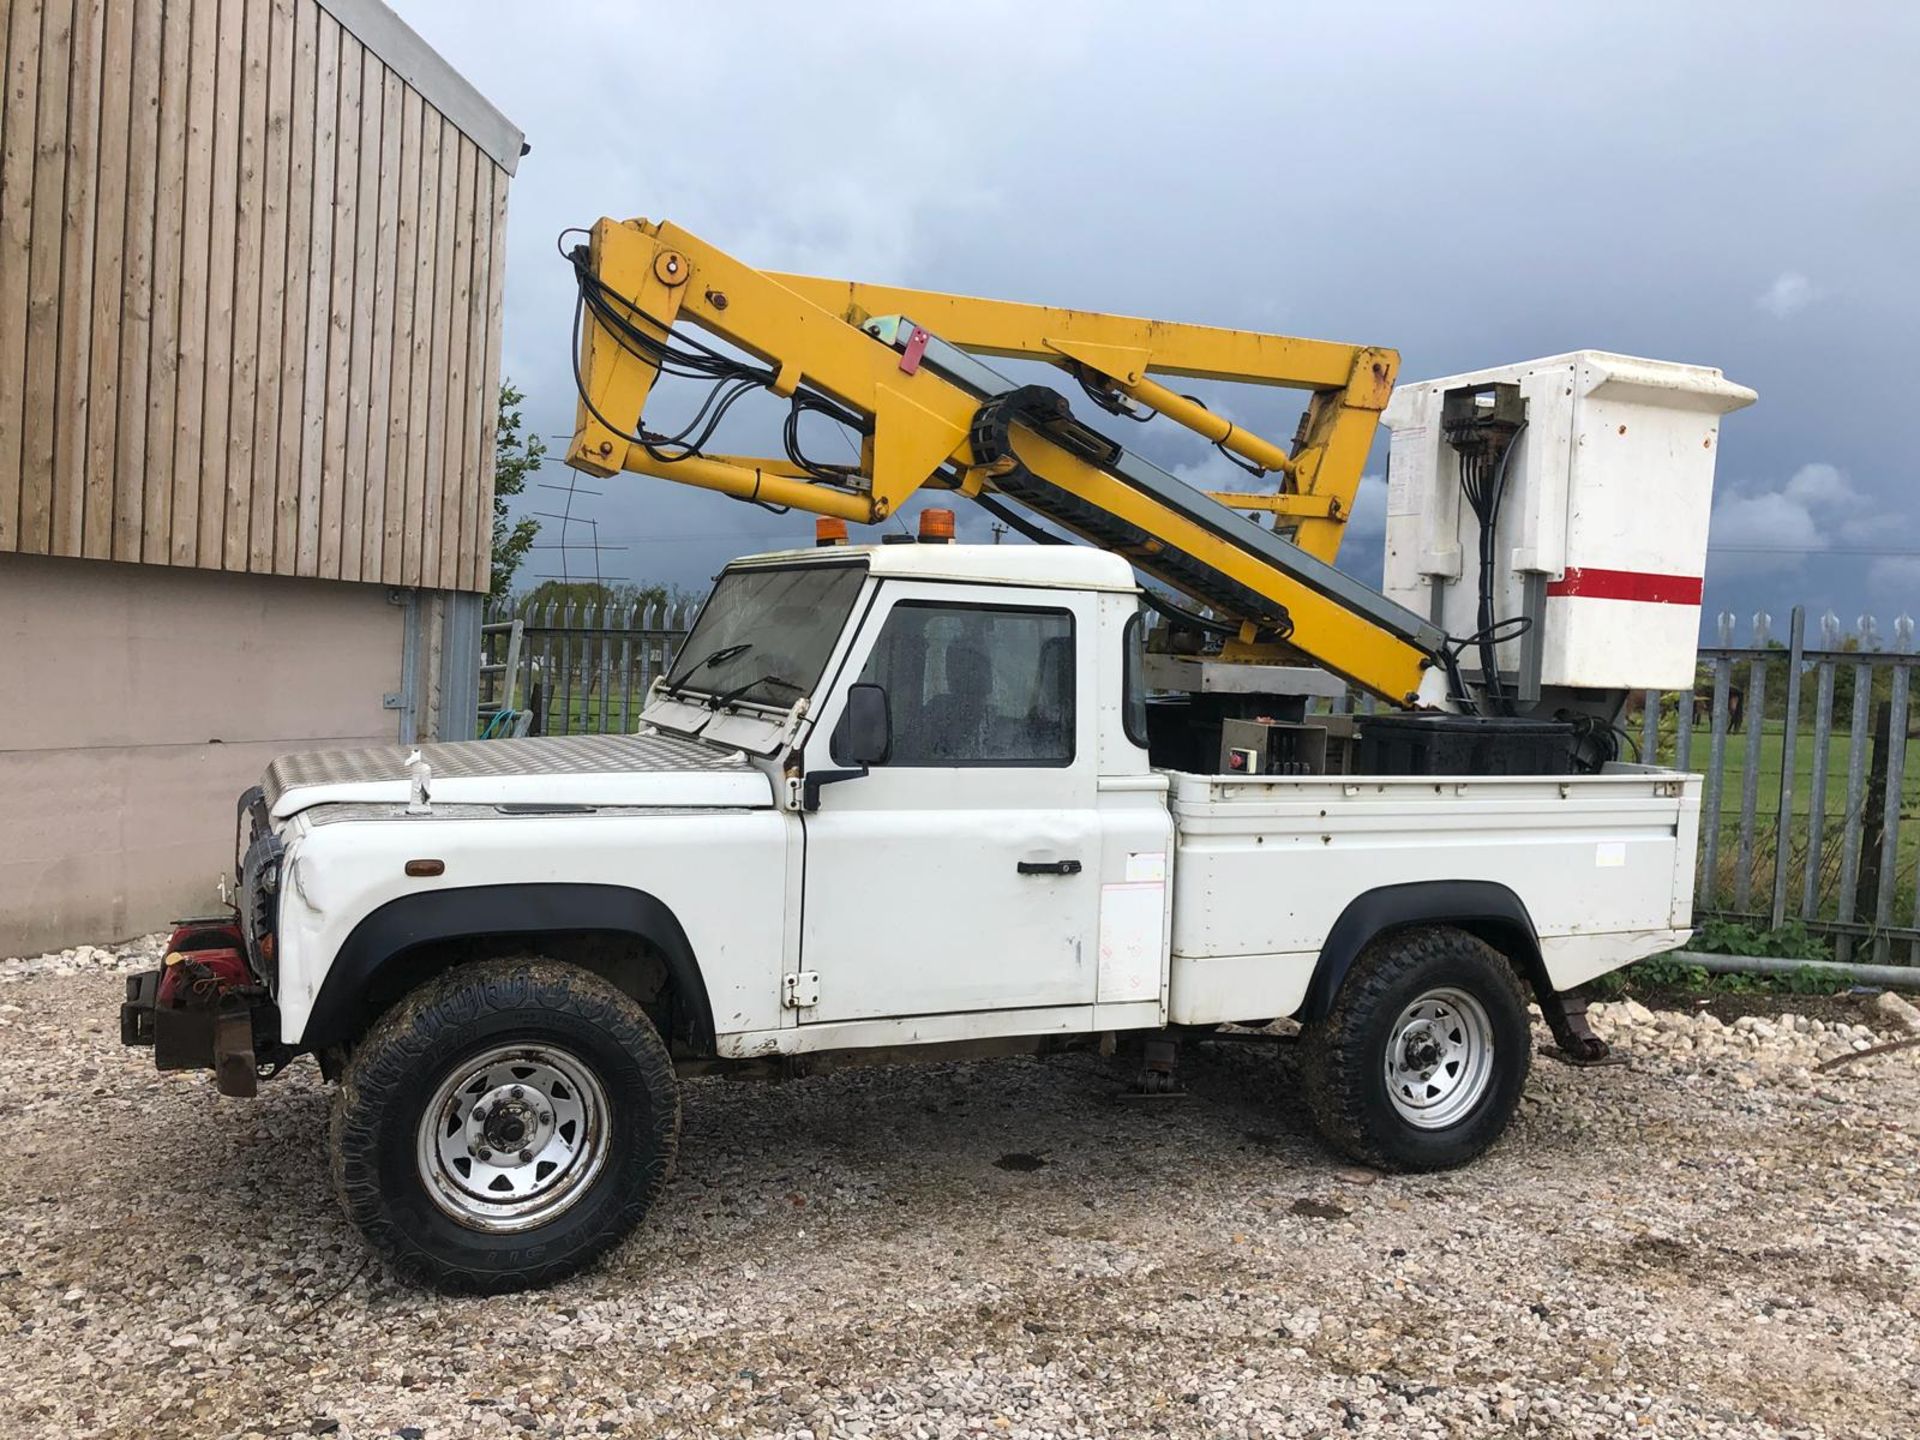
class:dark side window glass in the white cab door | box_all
[831,601,1073,768]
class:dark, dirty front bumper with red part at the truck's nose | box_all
[121,920,286,1096]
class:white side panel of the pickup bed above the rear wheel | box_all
[1169,766,1699,1025]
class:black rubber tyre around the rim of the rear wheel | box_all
[1302,925,1532,1171]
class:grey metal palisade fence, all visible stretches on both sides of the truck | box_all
[480,587,1920,964]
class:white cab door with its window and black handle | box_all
[801,582,1100,1023]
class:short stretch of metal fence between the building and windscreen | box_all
[480,601,695,735]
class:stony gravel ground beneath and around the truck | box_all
[0,941,1920,1440]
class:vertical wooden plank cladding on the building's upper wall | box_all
[0,0,520,589]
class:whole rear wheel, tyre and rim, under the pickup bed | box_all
[1304,925,1532,1169]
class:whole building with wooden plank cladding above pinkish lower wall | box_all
[0,0,522,954]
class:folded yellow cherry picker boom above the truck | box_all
[566,219,1459,708]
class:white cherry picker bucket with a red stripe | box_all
[1382,359,1755,697]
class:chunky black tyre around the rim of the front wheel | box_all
[330,956,680,1294]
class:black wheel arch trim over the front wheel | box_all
[300,883,714,1050]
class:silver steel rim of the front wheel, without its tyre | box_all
[415,1043,609,1233]
